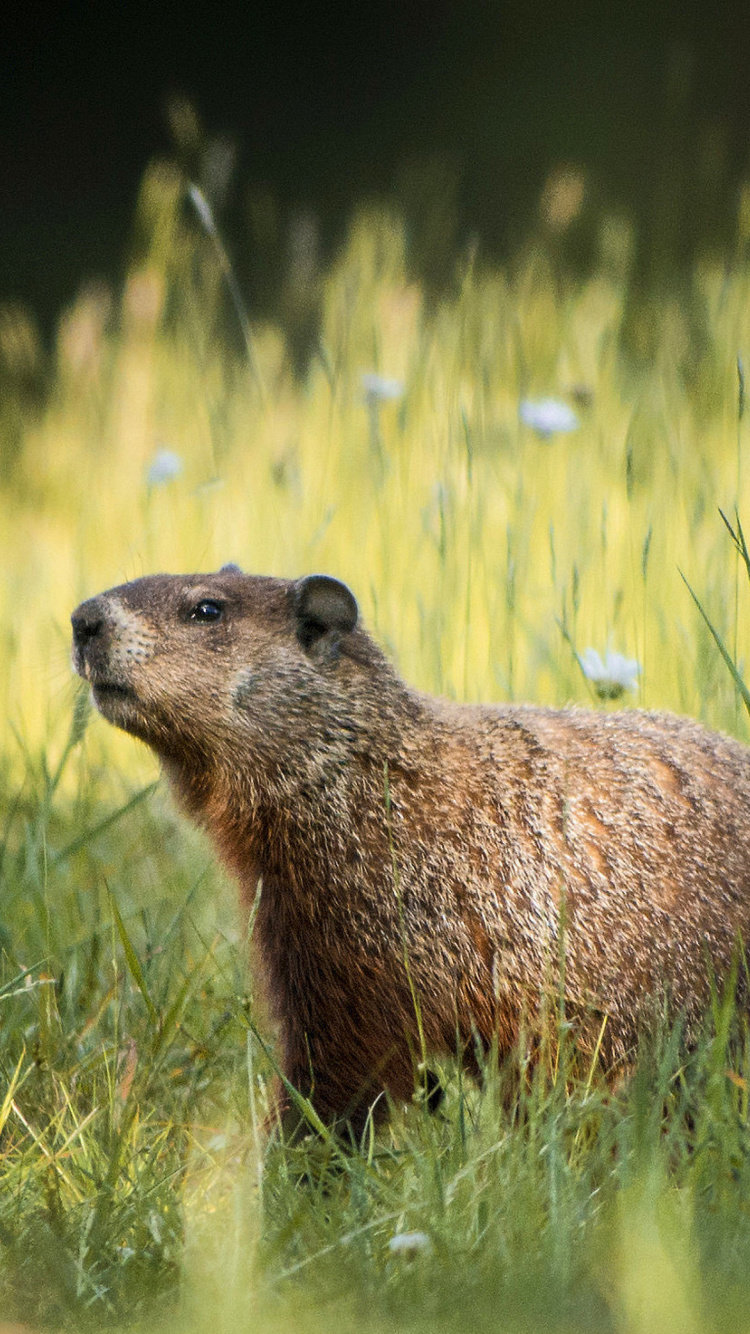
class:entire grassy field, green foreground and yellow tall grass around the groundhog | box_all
[0,168,750,1334]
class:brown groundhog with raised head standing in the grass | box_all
[72,566,750,1130]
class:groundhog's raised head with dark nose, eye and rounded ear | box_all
[72,566,381,767]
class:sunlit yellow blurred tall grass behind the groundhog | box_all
[0,168,750,776]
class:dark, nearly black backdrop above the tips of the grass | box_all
[0,0,750,324]
